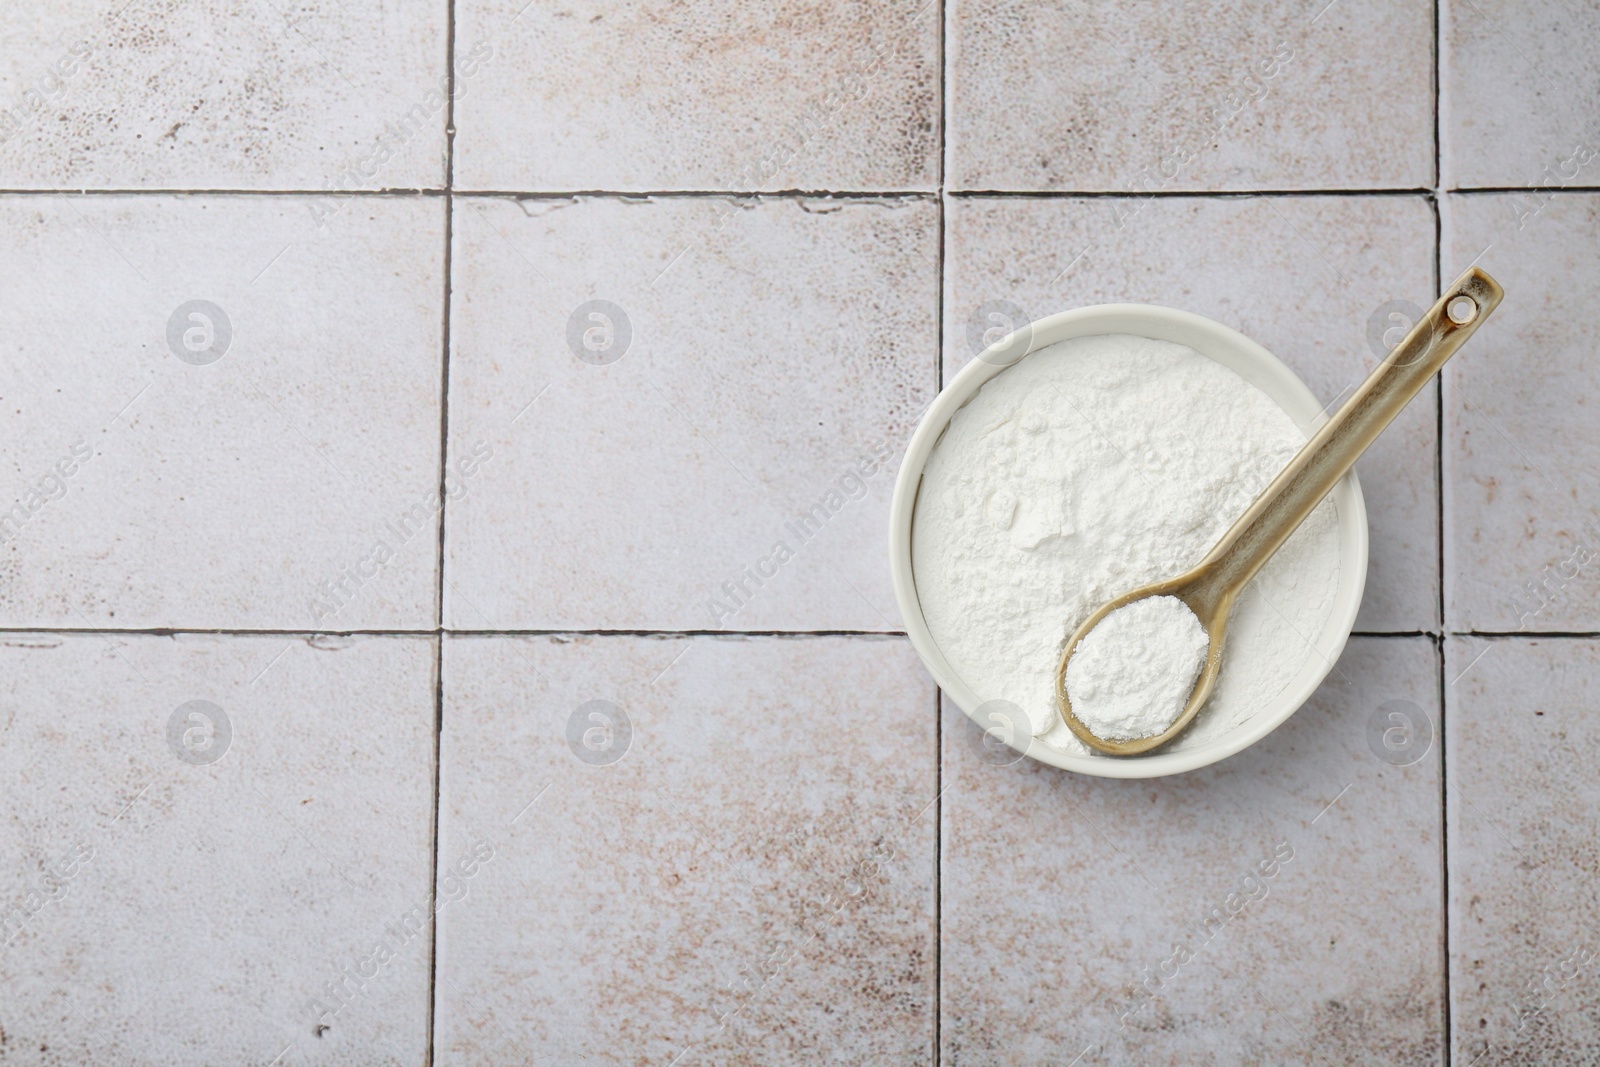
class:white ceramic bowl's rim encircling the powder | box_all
[890,304,1366,777]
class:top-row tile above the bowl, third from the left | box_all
[946,0,1434,192]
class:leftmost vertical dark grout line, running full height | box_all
[422,0,456,1067]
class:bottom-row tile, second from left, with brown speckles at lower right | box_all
[435,637,938,1064]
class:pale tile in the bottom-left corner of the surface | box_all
[0,633,434,1065]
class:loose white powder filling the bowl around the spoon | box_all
[912,334,1339,753]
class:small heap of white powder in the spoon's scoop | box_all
[1067,597,1211,741]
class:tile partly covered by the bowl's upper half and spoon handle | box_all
[944,197,1438,632]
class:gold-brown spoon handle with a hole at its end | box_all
[1195,267,1506,603]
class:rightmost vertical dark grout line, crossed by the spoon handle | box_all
[1429,0,1453,1064]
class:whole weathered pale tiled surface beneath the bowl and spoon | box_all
[0,0,1600,1067]
